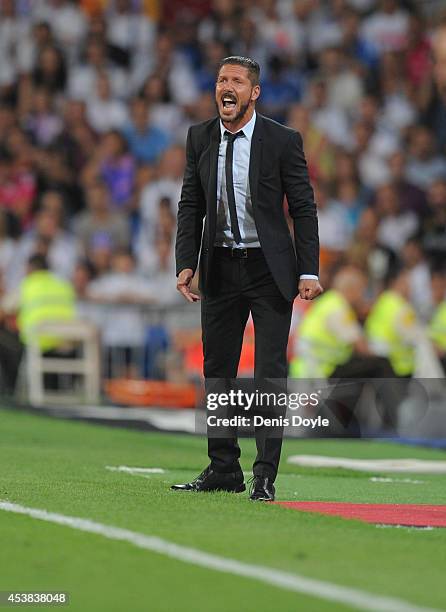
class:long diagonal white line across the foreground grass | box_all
[0,501,435,612]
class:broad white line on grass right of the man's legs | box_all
[287,455,446,474]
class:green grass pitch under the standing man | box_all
[0,410,446,612]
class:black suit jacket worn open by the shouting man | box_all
[175,114,319,301]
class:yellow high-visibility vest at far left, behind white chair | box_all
[17,270,75,351]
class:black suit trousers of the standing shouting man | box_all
[201,248,293,480]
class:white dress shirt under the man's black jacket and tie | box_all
[214,112,318,280]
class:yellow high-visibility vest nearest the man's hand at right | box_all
[290,289,356,378]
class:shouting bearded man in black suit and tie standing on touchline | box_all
[172,57,322,501]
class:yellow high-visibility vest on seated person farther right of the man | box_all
[365,290,417,376]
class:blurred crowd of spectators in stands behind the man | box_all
[0,0,446,382]
